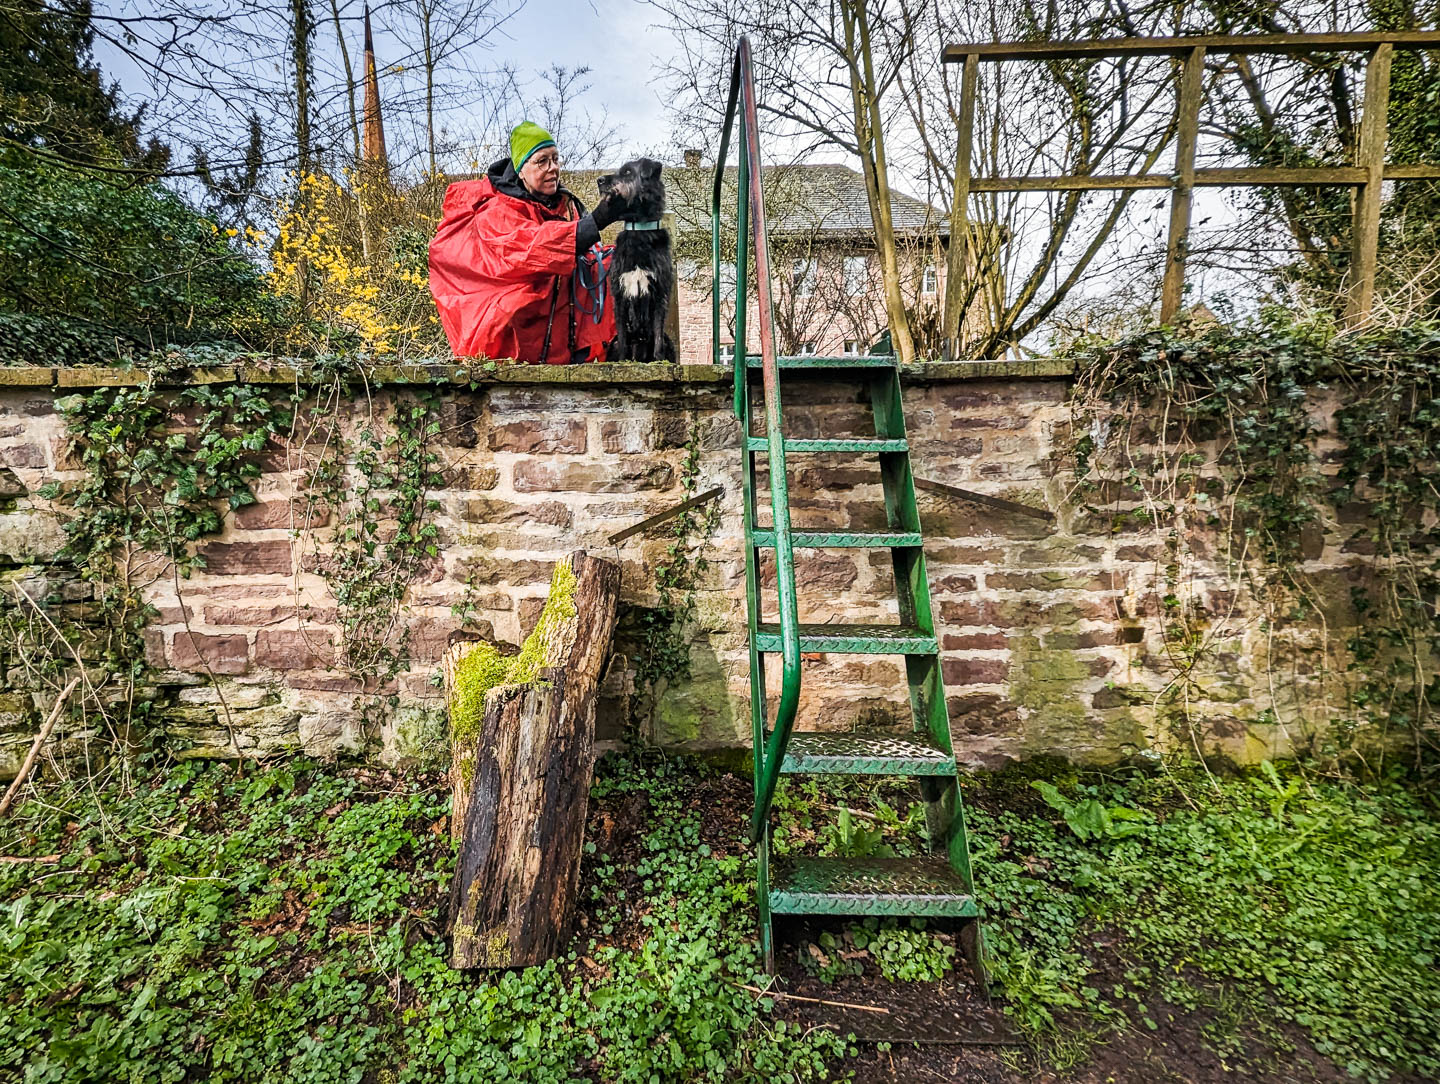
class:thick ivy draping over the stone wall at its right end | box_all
[1073,311,1440,757]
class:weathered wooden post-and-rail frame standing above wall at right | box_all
[940,30,1440,346]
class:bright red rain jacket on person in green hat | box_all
[431,160,615,366]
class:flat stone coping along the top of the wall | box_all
[0,358,1074,389]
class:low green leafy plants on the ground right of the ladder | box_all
[969,767,1440,1080]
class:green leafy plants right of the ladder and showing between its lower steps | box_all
[776,763,1440,1080]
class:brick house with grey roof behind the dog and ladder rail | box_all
[564,153,949,364]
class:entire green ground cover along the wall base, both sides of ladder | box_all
[0,754,1440,1084]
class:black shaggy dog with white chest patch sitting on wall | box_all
[596,158,675,361]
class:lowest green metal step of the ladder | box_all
[769,855,979,918]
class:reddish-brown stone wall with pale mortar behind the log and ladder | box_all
[0,363,1356,773]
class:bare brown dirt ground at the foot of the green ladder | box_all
[580,774,1352,1084]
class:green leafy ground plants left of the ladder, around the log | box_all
[0,762,845,1084]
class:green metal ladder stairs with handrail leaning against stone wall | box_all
[710,37,985,985]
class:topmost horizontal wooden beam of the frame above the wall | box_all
[940,30,1440,63]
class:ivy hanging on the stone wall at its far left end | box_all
[0,377,289,736]
